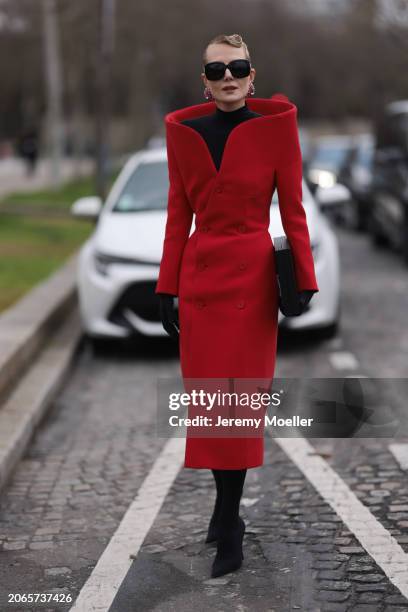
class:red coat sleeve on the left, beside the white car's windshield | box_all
[155,123,193,295]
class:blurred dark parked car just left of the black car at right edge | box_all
[337,133,375,231]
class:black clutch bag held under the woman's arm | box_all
[273,235,302,317]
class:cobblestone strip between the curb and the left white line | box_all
[0,343,178,612]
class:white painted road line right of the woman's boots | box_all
[273,438,408,598]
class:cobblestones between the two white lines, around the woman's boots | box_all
[111,438,408,612]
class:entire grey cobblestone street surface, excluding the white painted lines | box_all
[0,219,408,612]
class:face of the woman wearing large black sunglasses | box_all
[201,43,255,110]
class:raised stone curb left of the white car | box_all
[0,252,82,491]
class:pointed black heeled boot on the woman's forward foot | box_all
[211,517,245,578]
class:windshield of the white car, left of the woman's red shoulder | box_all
[112,160,169,212]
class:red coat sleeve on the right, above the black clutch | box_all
[275,113,319,291]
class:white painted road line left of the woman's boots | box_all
[71,437,185,612]
